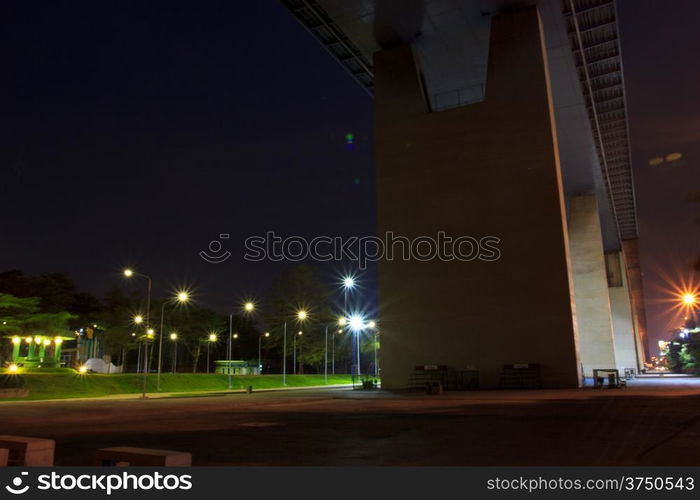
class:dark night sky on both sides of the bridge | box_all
[0,0,700,352]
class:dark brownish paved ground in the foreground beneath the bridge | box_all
[0,379,700,465]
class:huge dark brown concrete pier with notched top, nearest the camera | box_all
[374,8,580,388]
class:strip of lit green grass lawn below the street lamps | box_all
[0,369,352,401]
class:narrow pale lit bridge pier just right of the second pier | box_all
[606,252,641,373]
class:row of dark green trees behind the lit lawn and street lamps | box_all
[0,265,375,373]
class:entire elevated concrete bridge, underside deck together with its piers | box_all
[283,0,646,388]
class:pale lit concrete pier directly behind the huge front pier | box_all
[569,194,617,377]
